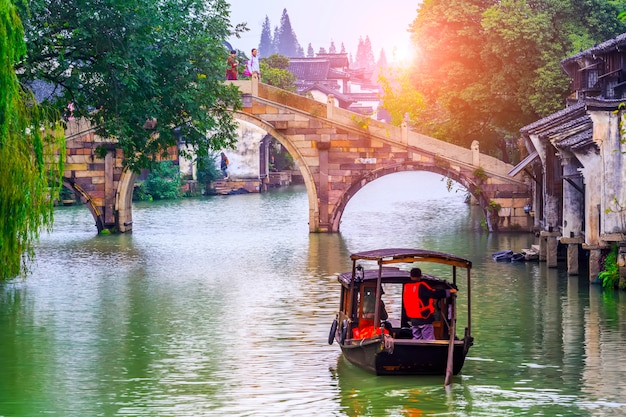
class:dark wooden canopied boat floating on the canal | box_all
[328,249,473,385]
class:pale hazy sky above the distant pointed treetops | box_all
[229,0,421,62]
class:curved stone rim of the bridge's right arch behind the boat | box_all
[331,161,491,232]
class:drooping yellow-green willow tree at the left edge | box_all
[0,0,64,280]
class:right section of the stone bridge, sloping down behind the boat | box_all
[235,81,530,232]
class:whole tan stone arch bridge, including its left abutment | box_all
[63,79,532,232]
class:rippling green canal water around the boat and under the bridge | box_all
[0,173,626,417]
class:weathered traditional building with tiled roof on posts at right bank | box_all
[510,34,626,281]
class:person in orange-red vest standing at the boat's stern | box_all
[402,268,456,340]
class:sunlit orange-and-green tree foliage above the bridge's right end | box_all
[398,0,626,160]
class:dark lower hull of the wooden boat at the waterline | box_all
[341,338,468,375]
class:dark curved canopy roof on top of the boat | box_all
[350,248,472,269]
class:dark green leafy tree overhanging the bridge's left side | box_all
[15,0,245,170]
